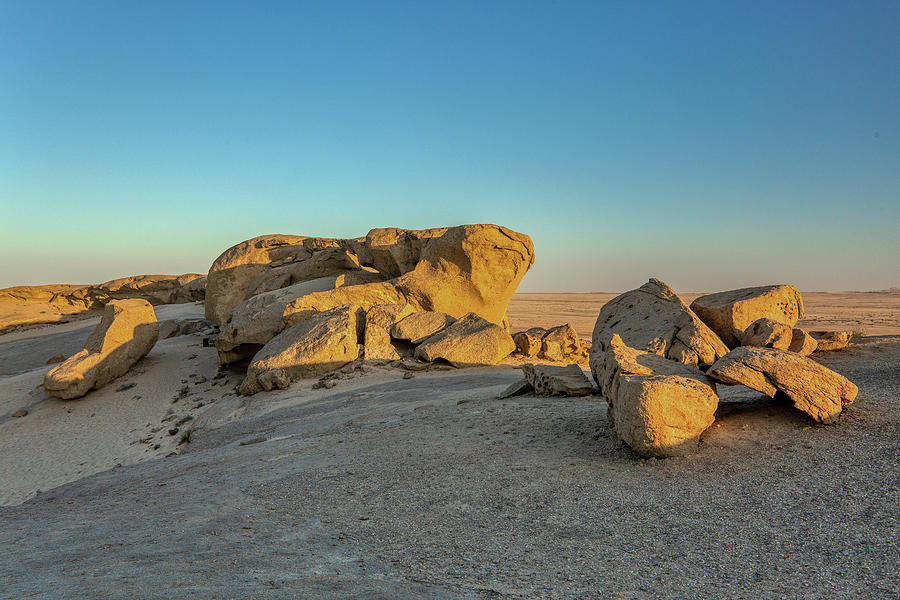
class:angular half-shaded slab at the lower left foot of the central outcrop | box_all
[240,306,359,396]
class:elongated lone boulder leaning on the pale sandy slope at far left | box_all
[44,299,159,400]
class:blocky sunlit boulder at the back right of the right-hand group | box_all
[691,285,803,348]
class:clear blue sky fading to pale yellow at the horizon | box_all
[0,0,900,291]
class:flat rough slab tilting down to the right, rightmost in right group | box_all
[707,346,858,423]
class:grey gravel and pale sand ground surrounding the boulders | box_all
[0,294,900,598]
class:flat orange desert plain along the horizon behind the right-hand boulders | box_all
[507,292,900,338]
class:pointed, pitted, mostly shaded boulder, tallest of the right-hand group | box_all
[591,279,728,383]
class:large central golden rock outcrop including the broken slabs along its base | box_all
[206,225,534,395]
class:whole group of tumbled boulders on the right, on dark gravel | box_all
[590,279,857,457]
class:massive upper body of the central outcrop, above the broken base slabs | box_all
[206,225,534,362]
